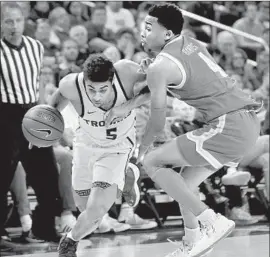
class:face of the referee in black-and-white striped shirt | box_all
[1,8,24,41]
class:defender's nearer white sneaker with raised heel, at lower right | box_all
[187,214,235,257]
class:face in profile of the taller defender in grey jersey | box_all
[141,15,166,52]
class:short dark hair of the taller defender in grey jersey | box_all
[148,3,184,35]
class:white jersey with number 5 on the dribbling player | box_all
[76,73,136,147]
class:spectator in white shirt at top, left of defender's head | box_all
[105,1,135,33]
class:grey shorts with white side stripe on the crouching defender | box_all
[178,110,259,170]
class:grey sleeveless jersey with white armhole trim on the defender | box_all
[159,36,261,122]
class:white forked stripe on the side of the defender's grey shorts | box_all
[186,114,226,169]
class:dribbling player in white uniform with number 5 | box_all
[50,54,149,257]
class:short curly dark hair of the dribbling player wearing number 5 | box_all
[83,54,115,82]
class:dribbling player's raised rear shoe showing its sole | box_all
[123,163,141,207]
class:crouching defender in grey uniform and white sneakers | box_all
[139,3,261,257]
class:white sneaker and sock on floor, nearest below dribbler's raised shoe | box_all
[118,203,158,230]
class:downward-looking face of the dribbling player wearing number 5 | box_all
[85,80,113,108]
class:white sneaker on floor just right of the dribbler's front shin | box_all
[95,213,130,234]
